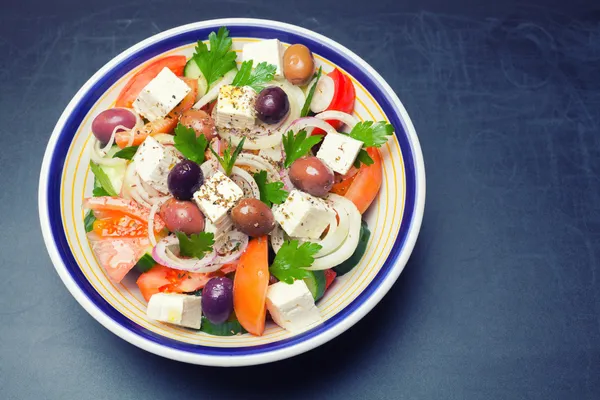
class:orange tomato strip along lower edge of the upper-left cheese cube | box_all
[115,78,198,148]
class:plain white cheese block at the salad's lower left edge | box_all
[146,293,202,329]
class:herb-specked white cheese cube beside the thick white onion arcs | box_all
[273,190,335,239]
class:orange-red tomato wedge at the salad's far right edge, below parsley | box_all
[344,147,383,214]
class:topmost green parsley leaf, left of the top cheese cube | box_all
[192,26,236,86]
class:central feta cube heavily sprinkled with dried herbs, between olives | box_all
[194,171,244,226]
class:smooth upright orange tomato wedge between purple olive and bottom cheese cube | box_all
[233,236,269,336]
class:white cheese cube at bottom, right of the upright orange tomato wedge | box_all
[267,280,322,332]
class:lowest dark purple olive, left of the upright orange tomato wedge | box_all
[202,277,233,324]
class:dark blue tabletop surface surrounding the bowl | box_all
[0,0,600,399]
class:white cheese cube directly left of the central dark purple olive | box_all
[133,136,179,193]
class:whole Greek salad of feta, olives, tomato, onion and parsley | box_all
[83,27,394,336]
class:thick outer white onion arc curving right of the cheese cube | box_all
[306,193,361,271]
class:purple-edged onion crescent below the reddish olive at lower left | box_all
[152,235,221,273]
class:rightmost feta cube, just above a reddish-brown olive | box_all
[317,133,363,175]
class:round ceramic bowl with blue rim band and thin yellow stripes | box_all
[39,19,425,366]
